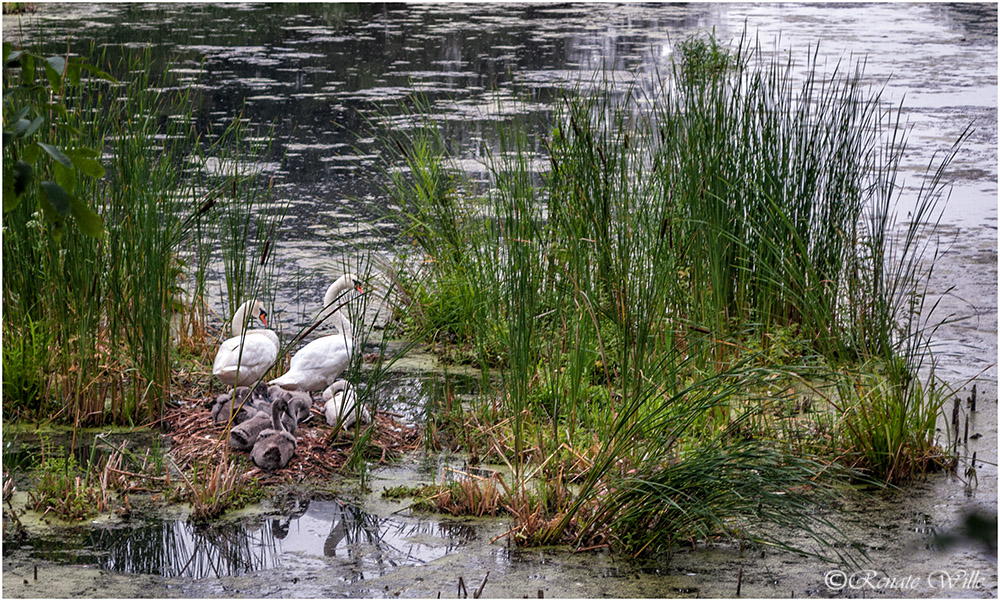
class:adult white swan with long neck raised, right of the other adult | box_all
[268,273,363,391]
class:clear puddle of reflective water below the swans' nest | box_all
[15,501,477,582]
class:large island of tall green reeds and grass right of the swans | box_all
[385,31,961,553]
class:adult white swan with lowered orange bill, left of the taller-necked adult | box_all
[212,299,279,386]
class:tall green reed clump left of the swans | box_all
[3,45,282,425]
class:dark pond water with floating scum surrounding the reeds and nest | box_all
[3,3,997,597]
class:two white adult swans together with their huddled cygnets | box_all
[212,273,371,471]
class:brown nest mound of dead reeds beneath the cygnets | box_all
[163,401,420,483]
